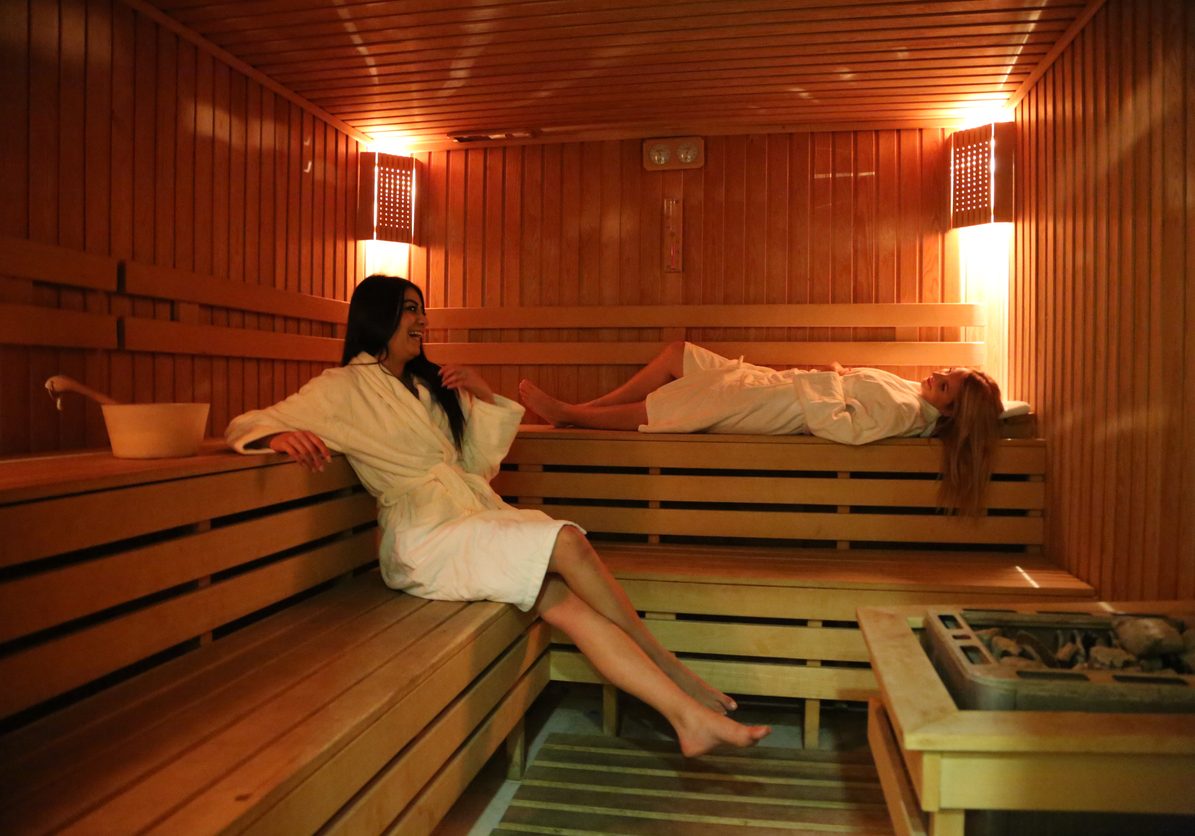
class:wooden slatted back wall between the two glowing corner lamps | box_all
[412,129,960,399]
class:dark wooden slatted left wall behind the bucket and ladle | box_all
[0,0,360,454]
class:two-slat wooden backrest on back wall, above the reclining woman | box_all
[428,298,983,367]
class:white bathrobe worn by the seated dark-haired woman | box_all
[225,354,578,610]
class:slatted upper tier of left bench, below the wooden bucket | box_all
[0,443,376,723]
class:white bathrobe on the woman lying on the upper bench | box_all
[639,343,939,444]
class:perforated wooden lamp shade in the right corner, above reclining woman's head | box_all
[950,122,1017,227]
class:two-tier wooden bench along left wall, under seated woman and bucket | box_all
[0,442,549,834]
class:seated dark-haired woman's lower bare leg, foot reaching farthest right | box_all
[537,574,772,757]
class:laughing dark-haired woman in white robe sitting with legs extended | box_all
[226,276,770,756]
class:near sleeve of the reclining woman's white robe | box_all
[793,371,919,444]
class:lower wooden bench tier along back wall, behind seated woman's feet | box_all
[551,543,1096,746]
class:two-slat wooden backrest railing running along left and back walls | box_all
[0,231,983,367]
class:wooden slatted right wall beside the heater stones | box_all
[1010,0,1195,600]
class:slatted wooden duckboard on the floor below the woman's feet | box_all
[494,734,891,836]
